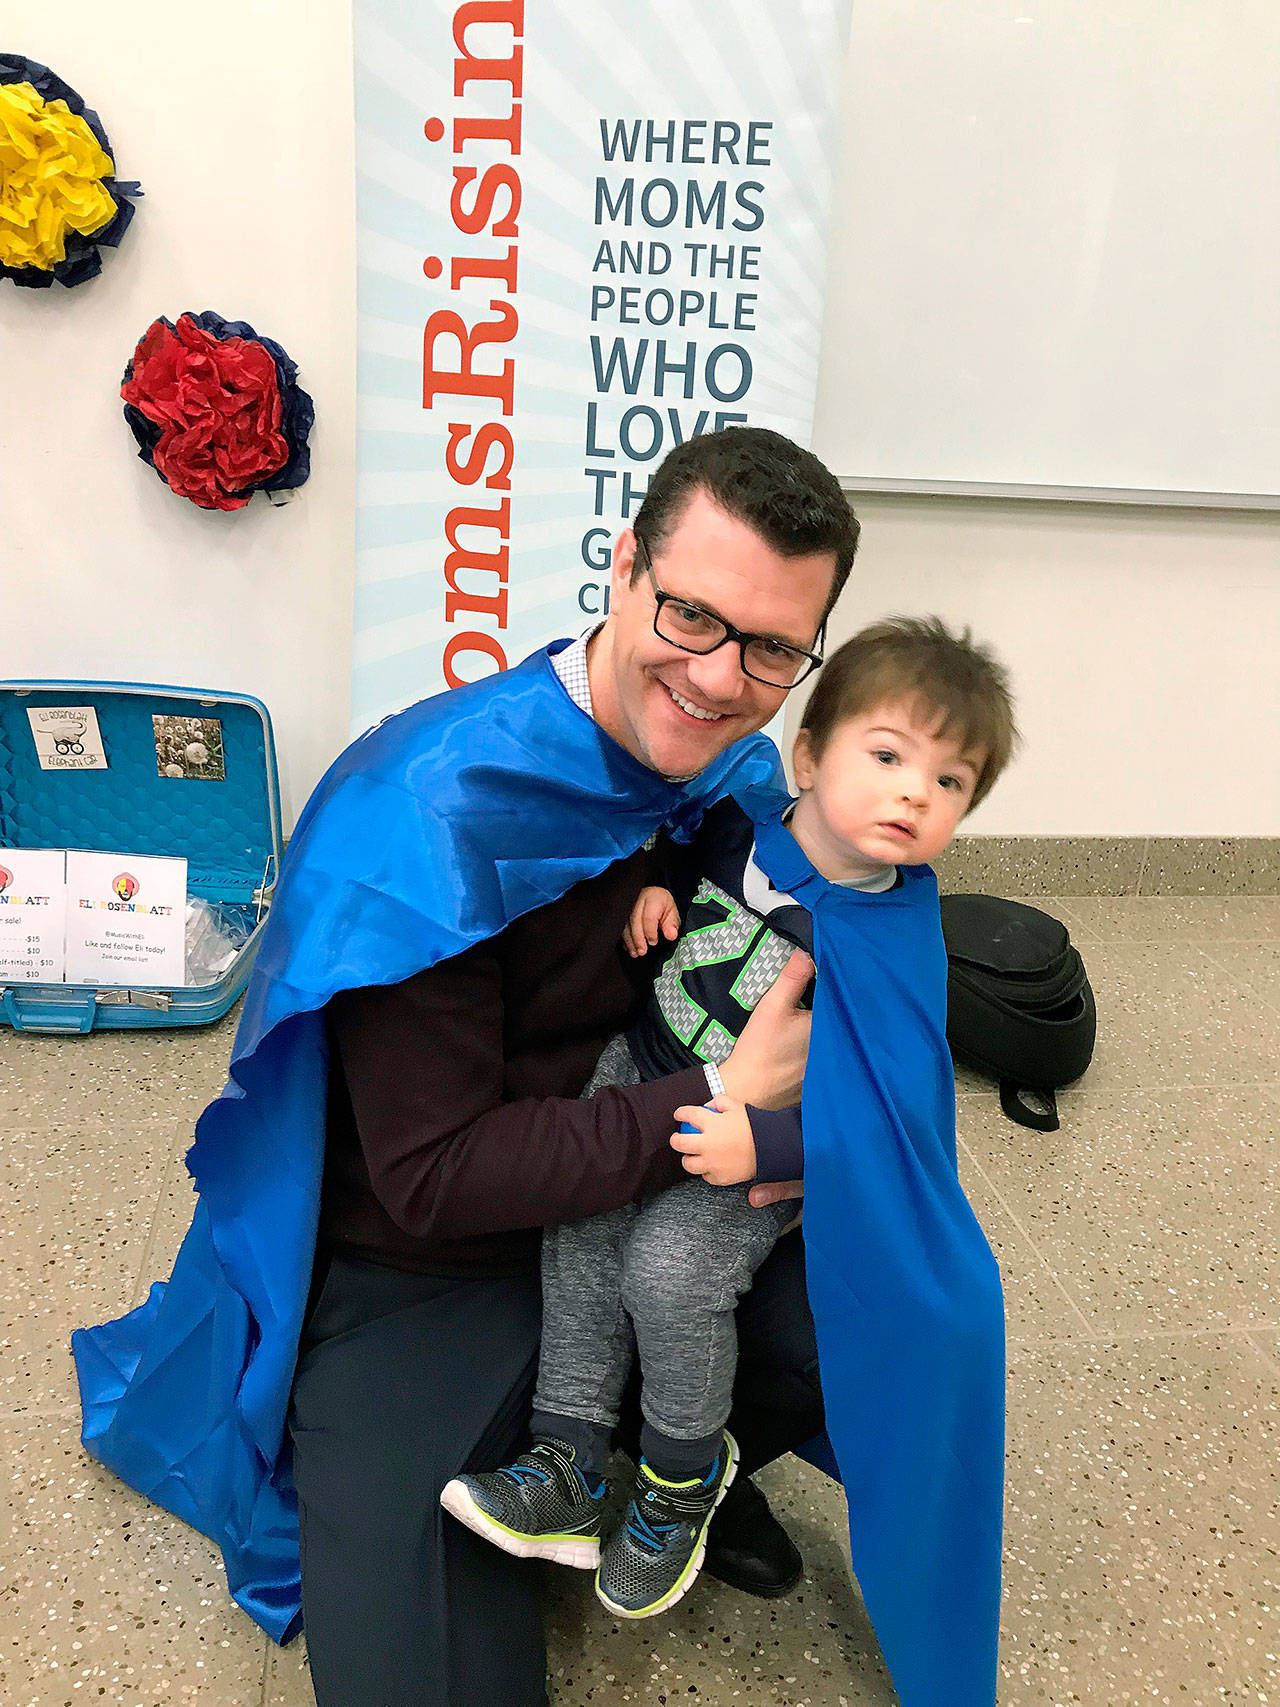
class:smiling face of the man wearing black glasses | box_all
[587,492,836,777]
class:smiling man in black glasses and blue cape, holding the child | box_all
[77,428,858,1707]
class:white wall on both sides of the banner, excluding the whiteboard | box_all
[0,10,1280,835]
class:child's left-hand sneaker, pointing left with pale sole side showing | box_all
[440,1441,604,1570]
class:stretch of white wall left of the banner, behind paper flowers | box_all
[0,0,355,823]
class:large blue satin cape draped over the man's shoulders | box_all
[72,647,780,1642]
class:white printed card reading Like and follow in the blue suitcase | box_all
[67,852,186,988]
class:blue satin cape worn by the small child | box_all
[739,797,1005,1707]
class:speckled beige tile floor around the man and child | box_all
[0,896,1280,1707]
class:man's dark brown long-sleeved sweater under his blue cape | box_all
[321,850,707,1275]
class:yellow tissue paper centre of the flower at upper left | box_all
[0,84,116,270]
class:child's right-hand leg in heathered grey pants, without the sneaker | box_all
[623,1180,795,1480]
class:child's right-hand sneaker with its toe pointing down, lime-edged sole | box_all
[596,1434,737,1618]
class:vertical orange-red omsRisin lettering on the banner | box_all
[422,0,524,688]
